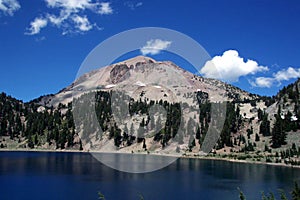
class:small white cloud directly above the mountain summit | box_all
[141,39,172,55]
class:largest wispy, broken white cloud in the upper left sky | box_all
[28,0,113,35]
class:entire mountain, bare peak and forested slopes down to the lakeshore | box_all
[0,56,300,164]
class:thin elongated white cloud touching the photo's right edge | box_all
[249,67,300,88]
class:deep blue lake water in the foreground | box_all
[0,152,300,200]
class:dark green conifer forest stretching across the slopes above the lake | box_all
[0,80,300,165]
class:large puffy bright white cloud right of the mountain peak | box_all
[200,50,268,82]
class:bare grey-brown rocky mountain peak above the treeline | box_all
[40,56,257,106]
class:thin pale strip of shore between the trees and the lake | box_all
[0,149,300,169]
